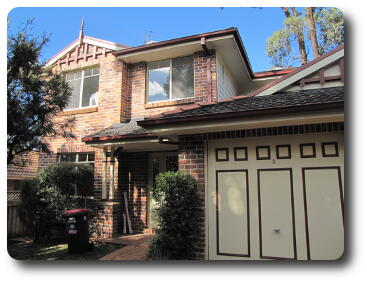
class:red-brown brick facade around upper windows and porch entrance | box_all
[31,38,217,241]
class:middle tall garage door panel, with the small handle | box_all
[257,168,297,259]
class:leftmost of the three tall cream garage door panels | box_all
[216,170,250,257]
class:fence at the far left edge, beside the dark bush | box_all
[8,191,25,236]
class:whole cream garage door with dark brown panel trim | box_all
[207,133,344,260]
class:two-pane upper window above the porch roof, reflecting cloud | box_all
[147,56,194,102]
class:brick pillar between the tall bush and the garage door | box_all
[178,134,206,259]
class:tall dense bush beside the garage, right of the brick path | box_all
[147,172,201,260]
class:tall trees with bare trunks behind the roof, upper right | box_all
[266,7,344,67]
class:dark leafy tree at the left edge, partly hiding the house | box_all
[7,21,73,165]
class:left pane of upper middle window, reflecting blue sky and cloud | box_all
[147,60,170,102]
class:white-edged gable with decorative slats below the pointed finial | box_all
[45,36,128,68]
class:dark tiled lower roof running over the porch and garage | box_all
[83,87,344,142]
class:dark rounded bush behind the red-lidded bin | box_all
[18,163,93,242]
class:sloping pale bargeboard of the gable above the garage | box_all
[256,48,344,96]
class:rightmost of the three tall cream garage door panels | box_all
[302,167,344,260]
